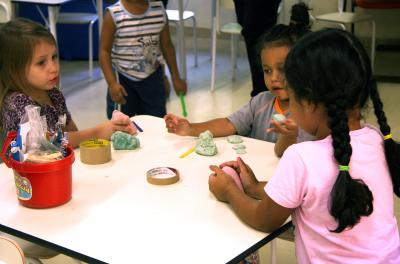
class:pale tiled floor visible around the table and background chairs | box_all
[26,34,400,264]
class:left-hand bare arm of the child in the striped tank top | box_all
[99,11,128,104]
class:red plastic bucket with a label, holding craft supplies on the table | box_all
[0,132,75,208]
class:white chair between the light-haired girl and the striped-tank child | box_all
[57,0,99,77]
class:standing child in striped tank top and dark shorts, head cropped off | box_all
[100,0,187,118]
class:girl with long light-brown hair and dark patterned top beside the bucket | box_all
[0,18,136,257]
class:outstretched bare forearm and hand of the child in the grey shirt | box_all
[164,114,236,137]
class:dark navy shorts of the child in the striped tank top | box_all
[107,67,167,119]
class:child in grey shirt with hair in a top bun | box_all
[164,3,311,156]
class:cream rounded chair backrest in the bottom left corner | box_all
[0,236,25,264]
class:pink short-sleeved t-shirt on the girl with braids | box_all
[265,126,400,264]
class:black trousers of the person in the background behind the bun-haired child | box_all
[234,0,280,96]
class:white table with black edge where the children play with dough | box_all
[0,116,288,264]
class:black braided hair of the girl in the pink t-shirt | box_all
[284,29,400,233]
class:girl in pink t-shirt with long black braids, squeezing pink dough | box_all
[209,29,400,263]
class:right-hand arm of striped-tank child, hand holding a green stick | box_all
[160,20,187,95]
